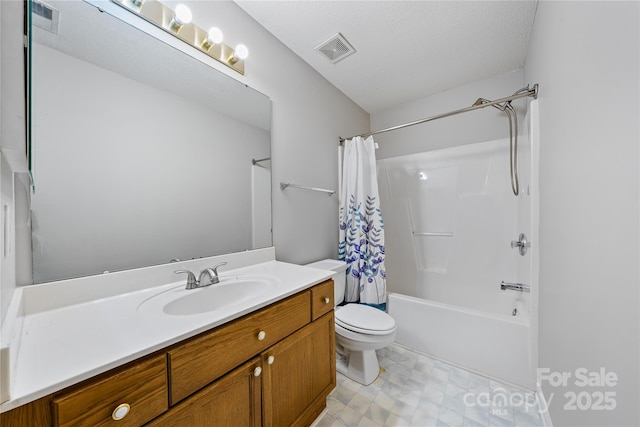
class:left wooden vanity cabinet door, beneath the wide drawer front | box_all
[146,357,262,427]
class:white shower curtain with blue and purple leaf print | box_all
[338,136,387,310]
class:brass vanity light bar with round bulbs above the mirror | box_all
[111,0,249,74]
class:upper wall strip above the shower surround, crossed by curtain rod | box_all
[371,69,534,159]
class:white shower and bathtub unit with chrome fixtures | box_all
[378,101,538,390]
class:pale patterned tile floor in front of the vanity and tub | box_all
[315,344,543,427]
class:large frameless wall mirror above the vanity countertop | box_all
[31,1,272,283]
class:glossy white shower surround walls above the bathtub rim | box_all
[378,137,533,314]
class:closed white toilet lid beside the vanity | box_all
[335,304,396,335]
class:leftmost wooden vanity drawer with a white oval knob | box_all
[52,354,168,427]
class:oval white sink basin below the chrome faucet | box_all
[138,276,279,316]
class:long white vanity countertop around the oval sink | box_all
[0,249,332,412]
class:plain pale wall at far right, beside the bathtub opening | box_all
[525,1,640,426]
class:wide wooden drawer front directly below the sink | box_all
[168,291,311,405]
